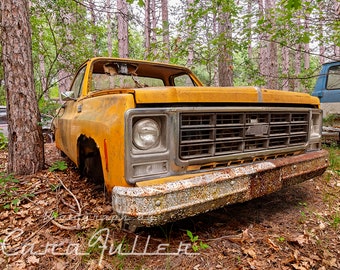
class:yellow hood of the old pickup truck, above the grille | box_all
[135,87,319,107]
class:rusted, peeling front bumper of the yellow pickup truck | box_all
[112,150,328,227]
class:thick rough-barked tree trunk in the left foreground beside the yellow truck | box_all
[1,0,44,174]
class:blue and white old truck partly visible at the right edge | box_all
[312,61,340,144]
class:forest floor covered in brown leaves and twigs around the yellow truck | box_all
[0,144,340,270]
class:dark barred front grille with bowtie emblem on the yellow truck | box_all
[179,110,309,160]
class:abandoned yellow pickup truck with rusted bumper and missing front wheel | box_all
[54,57,328,230]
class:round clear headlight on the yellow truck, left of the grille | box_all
[133,118,161,150]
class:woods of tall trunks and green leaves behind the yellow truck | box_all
[0,0,340,113]
